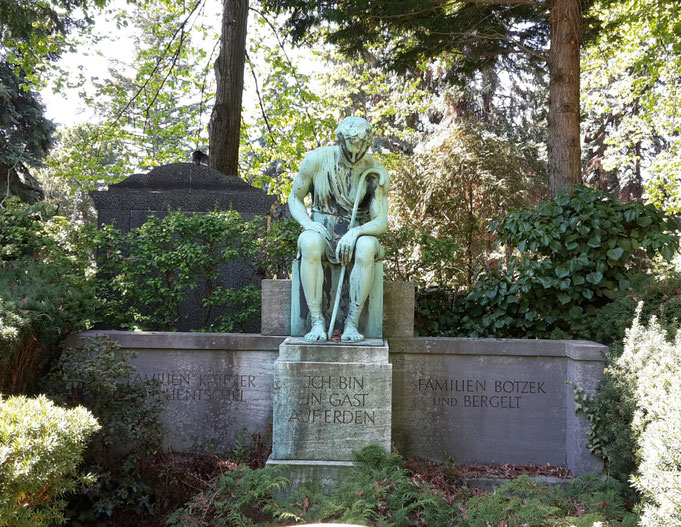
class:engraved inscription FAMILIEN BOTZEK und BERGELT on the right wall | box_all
[417,377,548,410]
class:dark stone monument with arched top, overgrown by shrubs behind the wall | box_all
[90,163,276,332]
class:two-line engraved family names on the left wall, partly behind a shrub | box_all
[131,372,258,402]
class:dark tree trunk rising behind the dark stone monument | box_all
[208,0,248,175]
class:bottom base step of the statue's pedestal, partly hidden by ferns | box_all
[266,457,354,497]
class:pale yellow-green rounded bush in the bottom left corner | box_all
[0,395,100,527]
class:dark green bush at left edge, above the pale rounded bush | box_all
[0,199,97,394]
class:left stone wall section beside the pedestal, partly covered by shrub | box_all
[68,331,280,452]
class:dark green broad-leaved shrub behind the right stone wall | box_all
[463,187,679,337]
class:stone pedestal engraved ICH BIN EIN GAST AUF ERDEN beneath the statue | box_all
[268,337,392,491]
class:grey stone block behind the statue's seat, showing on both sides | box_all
[260,280,414,338]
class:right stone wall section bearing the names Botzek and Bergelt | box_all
[390,338,605,475]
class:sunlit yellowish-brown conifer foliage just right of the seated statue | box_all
[386,125,538,288]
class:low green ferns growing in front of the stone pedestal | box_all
[168,445,636,527]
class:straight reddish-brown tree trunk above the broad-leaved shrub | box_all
[548,0,582,196]
